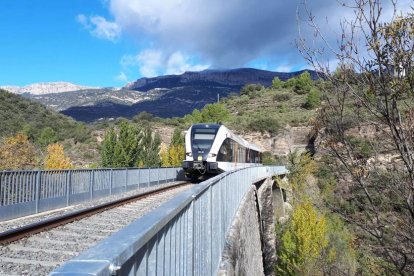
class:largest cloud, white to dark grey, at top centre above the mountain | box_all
[109,0,352,68]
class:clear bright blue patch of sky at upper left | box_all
[0,0,134,86]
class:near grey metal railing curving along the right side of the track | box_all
[51,167,287,275]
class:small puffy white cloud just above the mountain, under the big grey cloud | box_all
[121,49,209,77]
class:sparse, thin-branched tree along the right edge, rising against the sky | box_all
[299,0,414,274]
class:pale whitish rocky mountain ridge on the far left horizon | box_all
[0,82,98,95]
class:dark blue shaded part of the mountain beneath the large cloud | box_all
[62,68,317,122]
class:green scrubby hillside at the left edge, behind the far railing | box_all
[0,89,98,169]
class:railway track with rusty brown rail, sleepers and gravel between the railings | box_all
[0,183,191,275]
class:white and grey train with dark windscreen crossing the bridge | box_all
[183,124,262,179]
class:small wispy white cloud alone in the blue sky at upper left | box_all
[76,14,122,42]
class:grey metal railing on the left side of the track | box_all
[0,168,181,221]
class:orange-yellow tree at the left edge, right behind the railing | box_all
[0,133,36,170]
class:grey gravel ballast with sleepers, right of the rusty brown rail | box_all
[0,184,192,275]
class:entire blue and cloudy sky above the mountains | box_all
[0,0,412,87]
